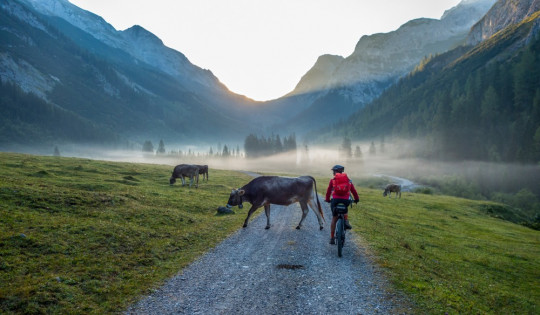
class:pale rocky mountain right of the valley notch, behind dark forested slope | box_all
[266,0,495,133]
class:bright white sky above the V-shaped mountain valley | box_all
[69,0,460,101]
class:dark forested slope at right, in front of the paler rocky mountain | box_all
[323,8,540,163]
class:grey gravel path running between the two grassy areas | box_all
[126,189,410,314]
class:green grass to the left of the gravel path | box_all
[0,153,250,314]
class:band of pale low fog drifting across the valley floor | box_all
[41,141,540,199]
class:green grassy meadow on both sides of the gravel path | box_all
[0,153,540,314]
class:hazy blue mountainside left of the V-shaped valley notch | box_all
[0,0,258,150]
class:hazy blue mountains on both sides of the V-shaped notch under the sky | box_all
[0,0,538,156]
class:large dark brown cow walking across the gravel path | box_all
[227,176,324,230]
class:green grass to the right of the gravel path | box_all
[346,188,540,314]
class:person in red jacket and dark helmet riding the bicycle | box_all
[325,165,360,245]
